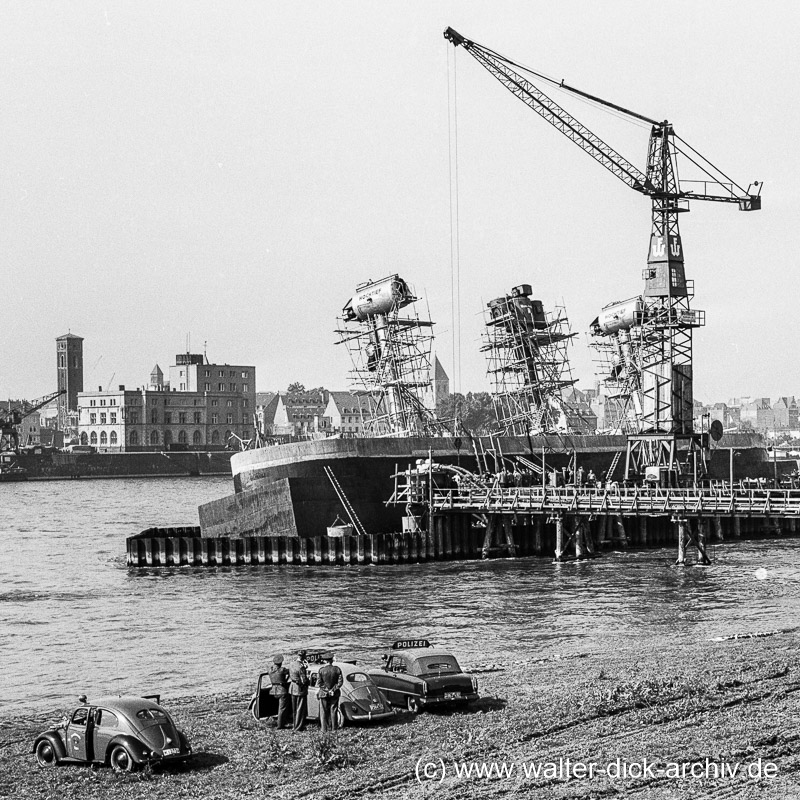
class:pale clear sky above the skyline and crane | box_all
[0,0,800,401]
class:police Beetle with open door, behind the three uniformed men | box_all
[250,653,394,728]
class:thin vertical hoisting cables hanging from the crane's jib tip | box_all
[447,47,461,400]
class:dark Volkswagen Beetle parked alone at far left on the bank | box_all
[33,695,192,772]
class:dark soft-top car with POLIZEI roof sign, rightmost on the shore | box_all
[369,639,478,714]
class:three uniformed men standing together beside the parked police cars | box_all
[269,650,344,733]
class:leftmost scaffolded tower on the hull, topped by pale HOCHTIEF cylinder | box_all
[336,275,446,436]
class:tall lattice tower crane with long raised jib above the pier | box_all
[444,28,762,472]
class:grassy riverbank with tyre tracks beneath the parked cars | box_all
[0,630,800,800]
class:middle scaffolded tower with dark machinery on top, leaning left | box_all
[481,284,578,436]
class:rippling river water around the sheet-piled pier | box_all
[0,478,800,714]
